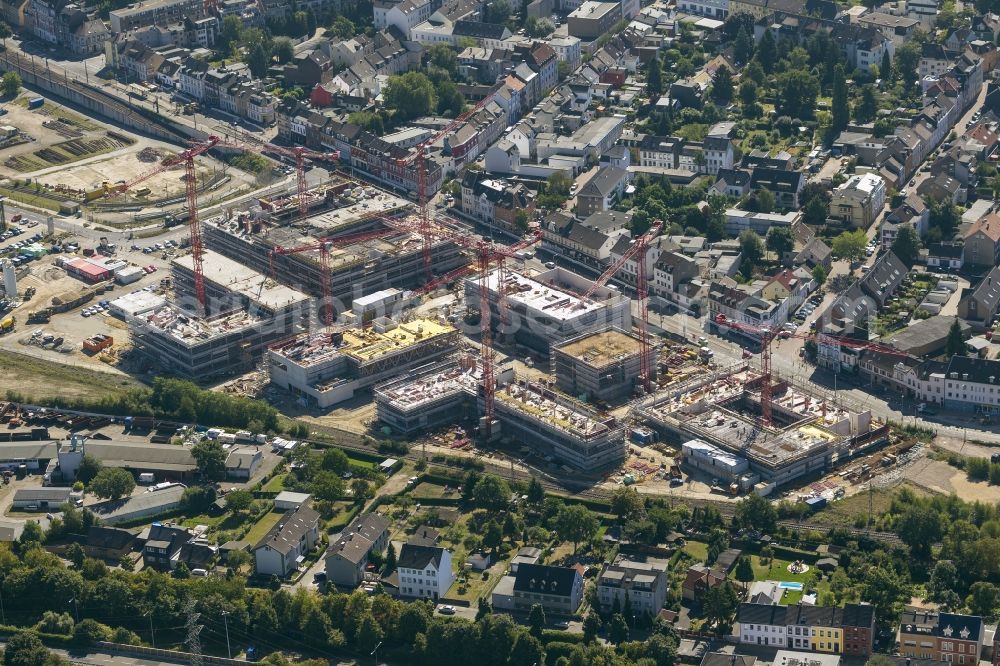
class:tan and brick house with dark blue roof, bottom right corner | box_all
[898,610,986,666]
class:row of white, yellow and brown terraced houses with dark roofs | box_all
[733,603,875,657]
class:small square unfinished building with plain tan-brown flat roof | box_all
[551,329,656,402]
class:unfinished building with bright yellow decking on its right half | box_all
[268,318,459,409]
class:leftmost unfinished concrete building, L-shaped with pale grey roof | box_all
[128,251,311,381]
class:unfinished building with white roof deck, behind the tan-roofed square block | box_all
[465,268,632,357]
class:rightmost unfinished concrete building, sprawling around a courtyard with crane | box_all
[640,364,888,490]
